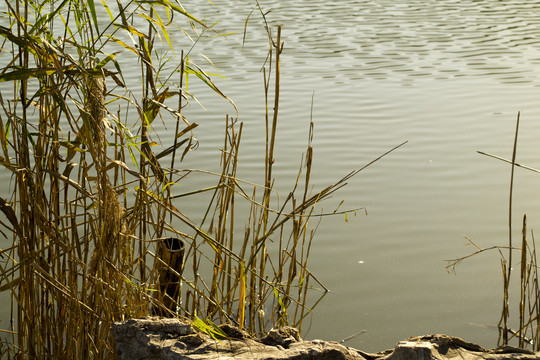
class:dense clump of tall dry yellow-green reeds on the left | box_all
[0,0,404,359]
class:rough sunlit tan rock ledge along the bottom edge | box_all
[112,318,540,360]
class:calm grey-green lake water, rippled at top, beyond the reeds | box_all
[5,0,540,351]
